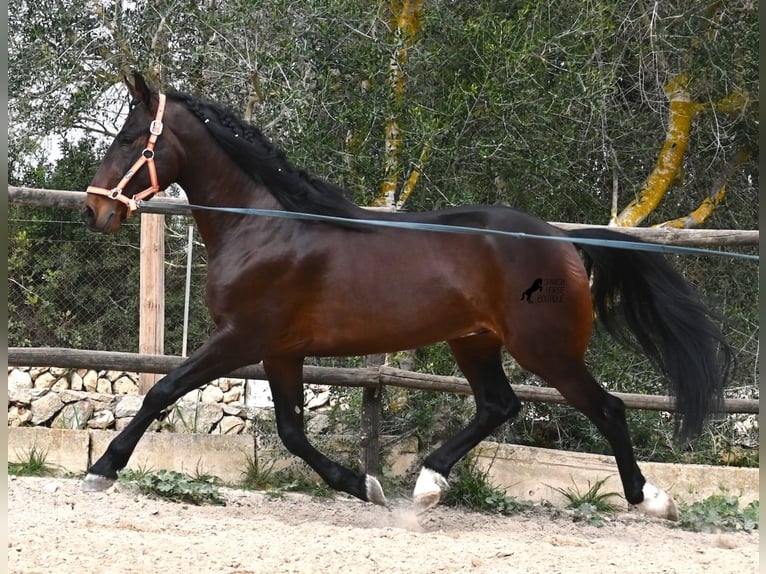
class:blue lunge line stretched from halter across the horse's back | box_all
[147,199,760,261]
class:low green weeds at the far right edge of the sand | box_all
[679,494,760,532]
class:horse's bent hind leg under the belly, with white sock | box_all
[413,333,521,508]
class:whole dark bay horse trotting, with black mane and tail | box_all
[81,73,731,519]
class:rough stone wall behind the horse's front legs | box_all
[8,367,332,434]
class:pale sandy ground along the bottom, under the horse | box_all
[8,477,758,574]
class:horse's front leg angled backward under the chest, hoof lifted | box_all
[263,358,388,506]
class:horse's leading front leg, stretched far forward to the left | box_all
[82,331,254,491]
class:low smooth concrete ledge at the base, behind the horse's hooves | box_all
[8,427,759,505]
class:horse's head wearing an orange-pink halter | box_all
[81,73,179,233]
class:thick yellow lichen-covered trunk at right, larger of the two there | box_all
[609,75,699,227]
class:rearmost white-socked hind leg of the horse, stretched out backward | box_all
[536,359,678,520]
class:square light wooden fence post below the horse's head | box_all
[138,214,165,395]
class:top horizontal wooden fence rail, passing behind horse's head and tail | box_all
[8,186,759,247]
